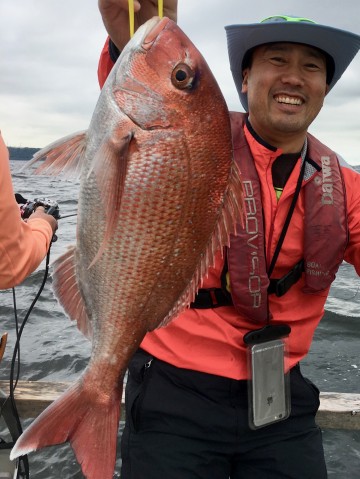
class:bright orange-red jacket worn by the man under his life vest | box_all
[99,40,360,379]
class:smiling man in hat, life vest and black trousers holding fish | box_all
[99,0,360,479]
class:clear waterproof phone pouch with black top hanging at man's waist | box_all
[244,325,291,429]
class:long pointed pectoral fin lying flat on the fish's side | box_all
[89,130,134,268]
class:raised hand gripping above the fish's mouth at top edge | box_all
[98,0,177,51]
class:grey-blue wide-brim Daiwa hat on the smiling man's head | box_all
[225,15,360,111]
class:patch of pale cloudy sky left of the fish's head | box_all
[0,0,106,147]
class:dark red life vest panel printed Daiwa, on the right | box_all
[304,135,348,294]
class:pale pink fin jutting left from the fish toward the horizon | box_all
[21,131,86,178]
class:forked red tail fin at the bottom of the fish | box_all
[10,380,122,479]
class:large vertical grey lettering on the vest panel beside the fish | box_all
[243,180,261,308]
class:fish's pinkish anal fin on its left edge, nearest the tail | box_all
[53,246,92,339]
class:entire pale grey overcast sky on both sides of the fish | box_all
[0,0,360,165]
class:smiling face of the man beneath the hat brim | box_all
[242,43,328,146]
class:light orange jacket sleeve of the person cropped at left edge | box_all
[0,135,53,289]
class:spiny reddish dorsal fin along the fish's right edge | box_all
[157,162,245,328]
